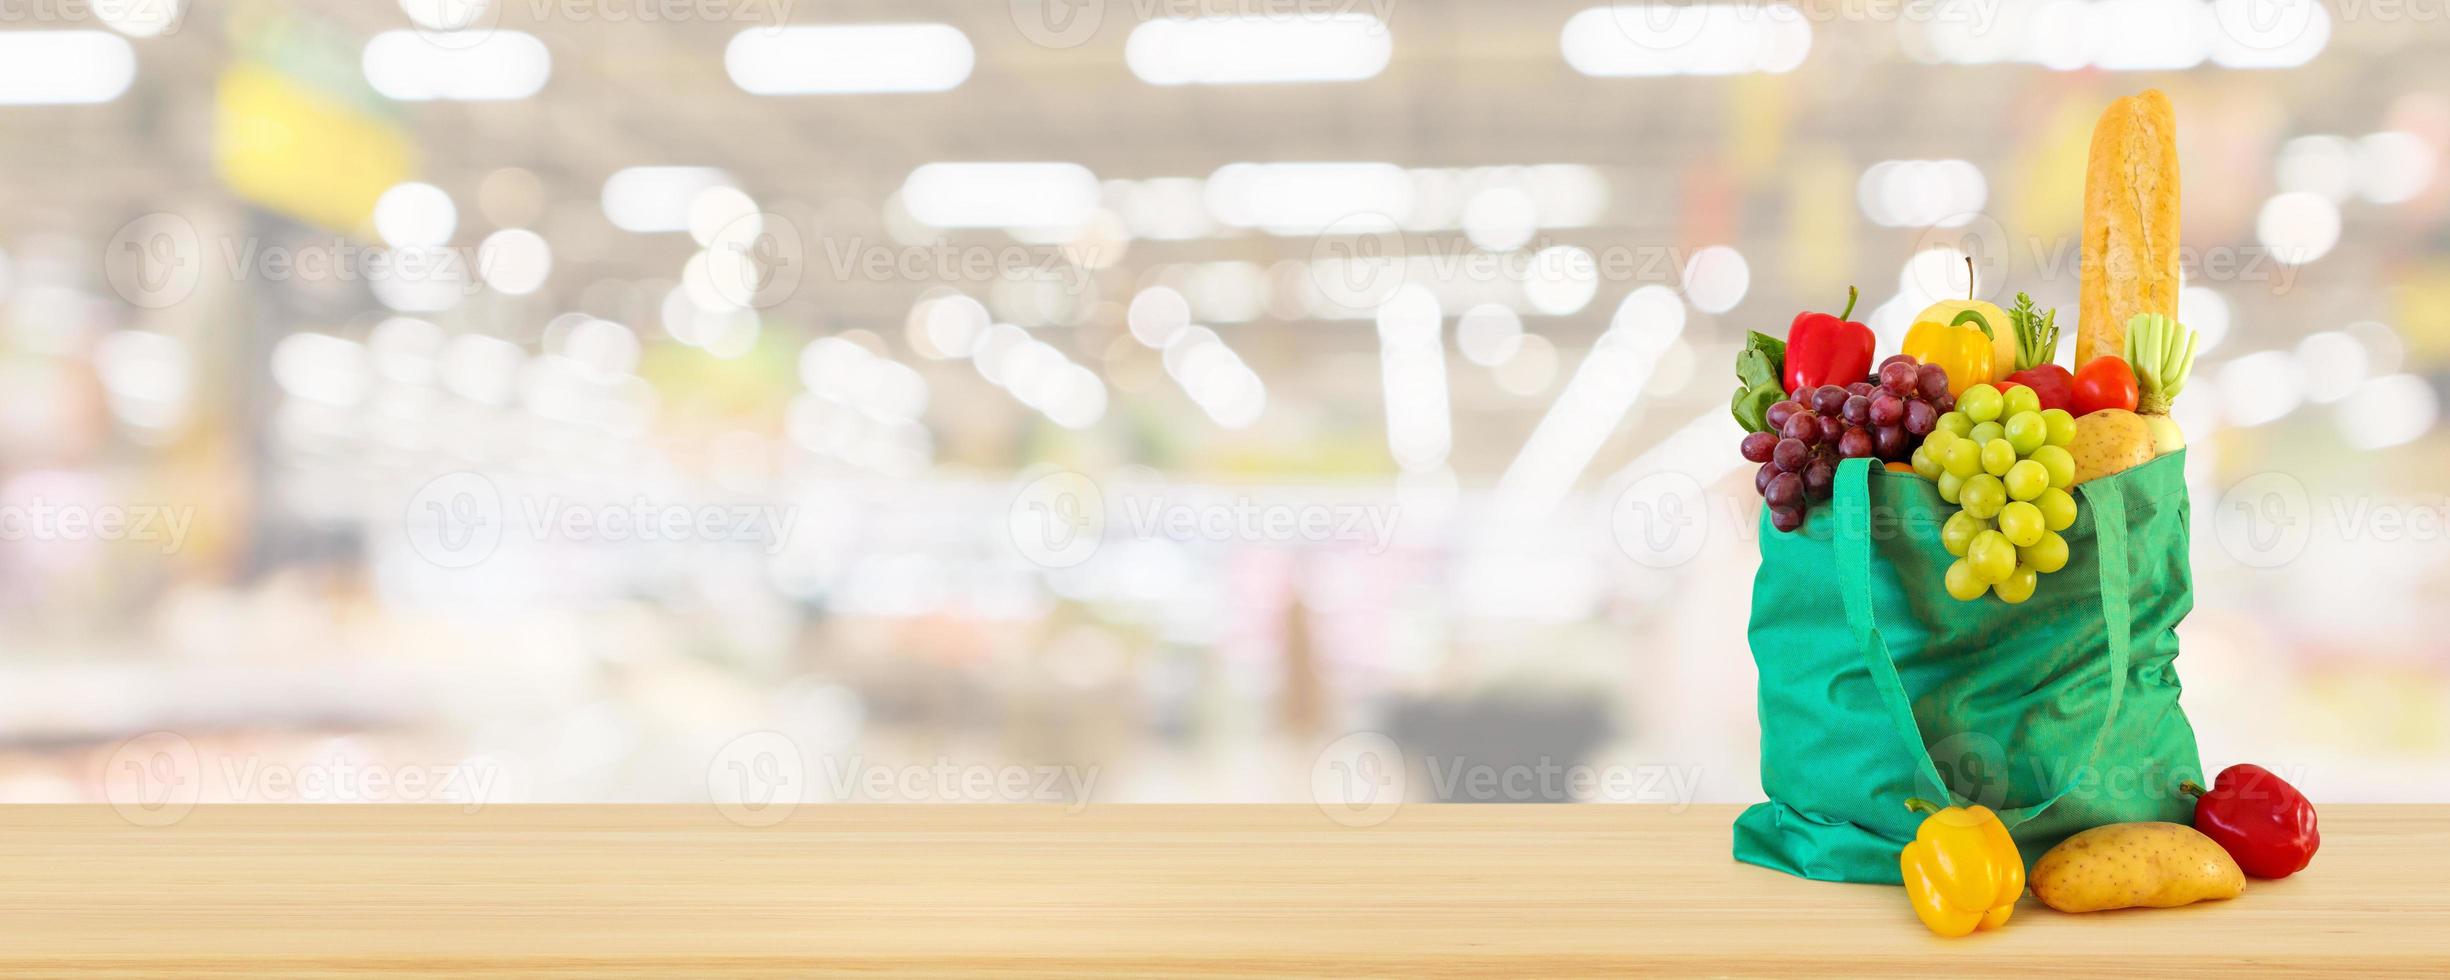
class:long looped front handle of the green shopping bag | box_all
[1835,458,2134,828]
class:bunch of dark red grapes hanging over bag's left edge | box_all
[1744,355,1958,532]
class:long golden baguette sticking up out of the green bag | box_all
[2075,88,2178,368]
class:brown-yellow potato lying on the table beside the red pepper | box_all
[2031,823,2247,911]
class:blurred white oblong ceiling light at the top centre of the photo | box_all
[1122,15,1394,86]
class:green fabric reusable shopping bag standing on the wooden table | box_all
[1735,453,2203,884]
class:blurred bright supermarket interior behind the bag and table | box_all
[0,0,2450,801]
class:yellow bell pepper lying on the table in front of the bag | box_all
[1896,799,2024,936]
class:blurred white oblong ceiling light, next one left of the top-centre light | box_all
[723,25,978,96]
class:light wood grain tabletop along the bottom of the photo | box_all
[0,806,2450,978]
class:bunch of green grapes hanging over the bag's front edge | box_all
[1913,385,2075,603]
